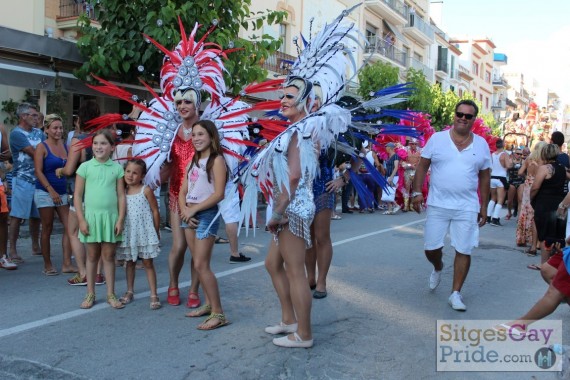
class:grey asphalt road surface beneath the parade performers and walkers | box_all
[0,209,570,379]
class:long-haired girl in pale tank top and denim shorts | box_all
[178,120,229,330]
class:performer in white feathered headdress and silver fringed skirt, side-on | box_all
[241,3,359,347]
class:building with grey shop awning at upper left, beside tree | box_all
[0,0,105,120]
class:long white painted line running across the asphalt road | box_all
[0,219,425,338]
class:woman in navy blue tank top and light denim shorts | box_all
[34,114,77,276]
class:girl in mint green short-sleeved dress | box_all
[74,130,126,309]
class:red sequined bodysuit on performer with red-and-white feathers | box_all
[168,134,194,212]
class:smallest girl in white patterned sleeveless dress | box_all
[117,160,161,310]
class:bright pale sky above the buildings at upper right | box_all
[431,0,570,103]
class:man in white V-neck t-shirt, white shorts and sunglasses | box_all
[411,100,491,311]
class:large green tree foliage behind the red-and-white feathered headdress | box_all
[75,0,287,93]
